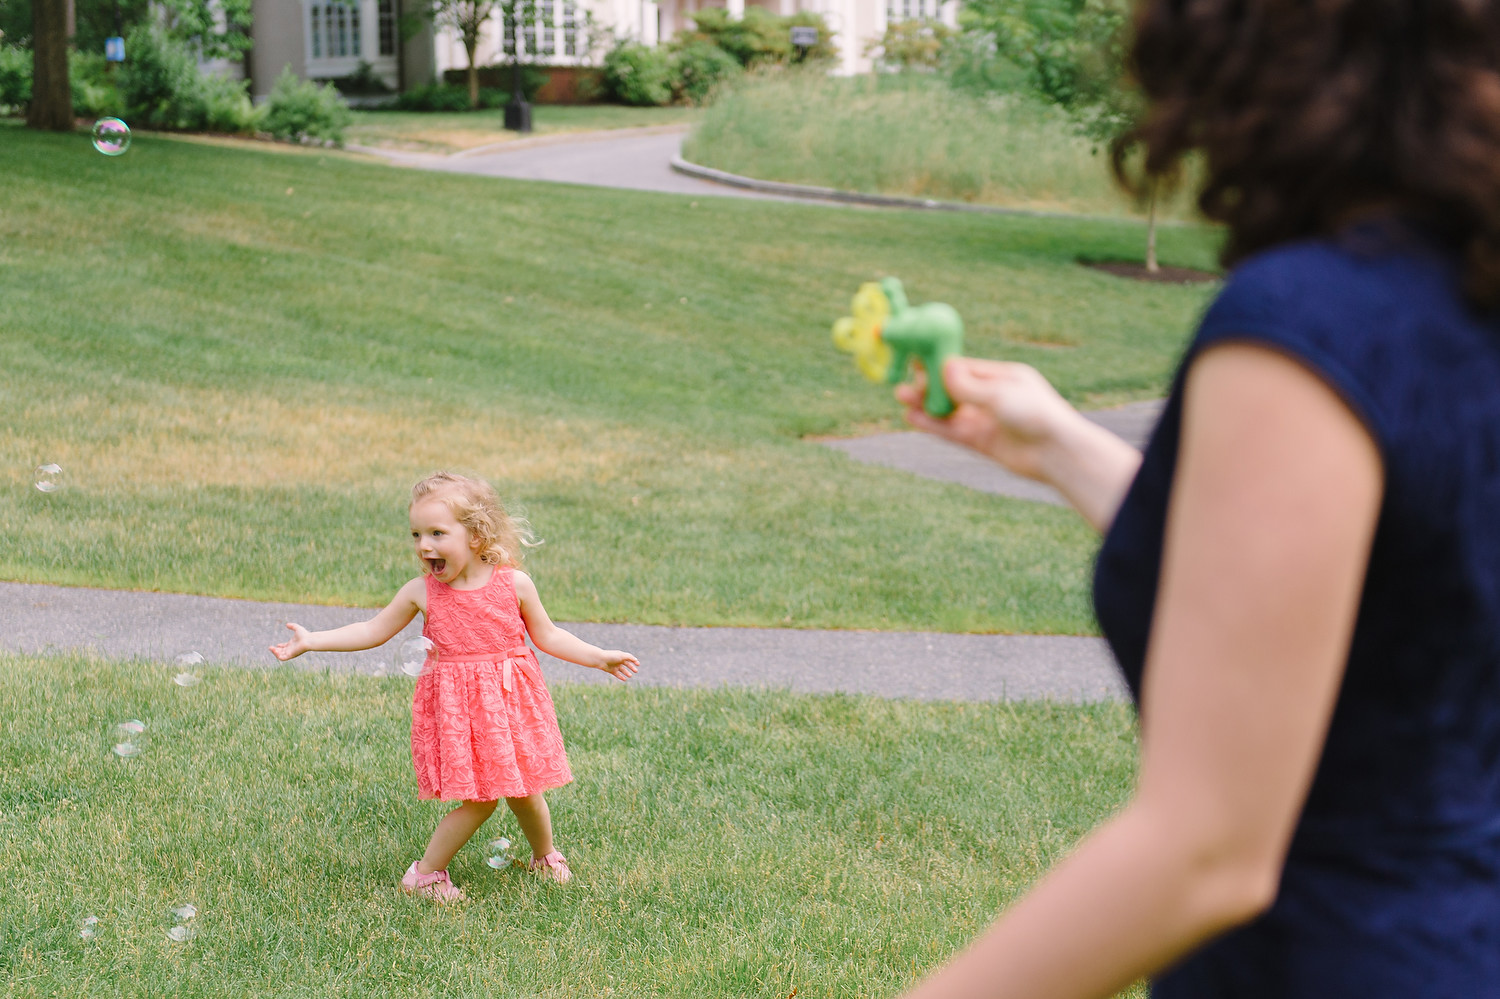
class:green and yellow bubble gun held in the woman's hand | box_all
[834,278,963,417]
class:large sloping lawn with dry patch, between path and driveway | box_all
[0,126,1217,633]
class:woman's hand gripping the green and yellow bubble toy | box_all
[896,357,1082,482]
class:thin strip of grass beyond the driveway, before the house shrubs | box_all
[345,104,701,153]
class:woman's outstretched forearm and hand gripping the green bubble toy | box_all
[896,357,1140,534]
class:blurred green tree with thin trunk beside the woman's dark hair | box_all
[959,0,1161,273]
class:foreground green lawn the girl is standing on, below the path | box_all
[0,656,1143,999]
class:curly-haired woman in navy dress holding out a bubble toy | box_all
[900,0,1500,999]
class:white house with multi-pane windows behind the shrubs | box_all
[246,0,959,96]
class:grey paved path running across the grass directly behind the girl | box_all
[0,584,1125,702]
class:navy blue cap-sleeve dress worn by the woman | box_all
[1094,224,1500,999]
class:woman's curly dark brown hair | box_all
[1113,0,1500,308]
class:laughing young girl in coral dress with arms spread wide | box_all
[270,473,641,902]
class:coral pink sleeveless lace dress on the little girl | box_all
[411,569,573,801]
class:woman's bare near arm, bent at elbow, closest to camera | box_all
[912,344,1383,999]
